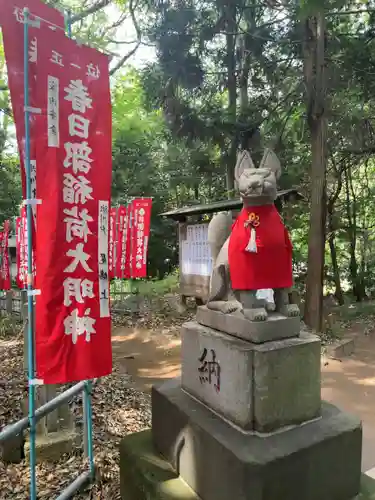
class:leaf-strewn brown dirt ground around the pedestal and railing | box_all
[0,304,375,500]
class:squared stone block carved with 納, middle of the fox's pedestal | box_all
[181,321,321,432]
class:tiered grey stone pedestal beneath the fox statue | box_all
[120,316,362,500]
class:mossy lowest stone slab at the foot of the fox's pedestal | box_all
[120,430,375,500]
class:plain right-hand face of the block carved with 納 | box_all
[253,332,321,432]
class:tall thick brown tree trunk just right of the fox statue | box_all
[304,12,327,332]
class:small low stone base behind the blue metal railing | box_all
[25,431,81,463]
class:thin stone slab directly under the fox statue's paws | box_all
[197,306,301,344]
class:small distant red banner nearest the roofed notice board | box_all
[132,198,152,278]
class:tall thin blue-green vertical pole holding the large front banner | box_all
[23,8,37,500]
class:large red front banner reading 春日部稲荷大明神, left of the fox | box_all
[36,32,112,384]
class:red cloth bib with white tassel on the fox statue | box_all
[229,204,293,290]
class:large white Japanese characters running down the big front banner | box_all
[61,75,99,344]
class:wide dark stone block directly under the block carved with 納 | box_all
[153,381,362,500]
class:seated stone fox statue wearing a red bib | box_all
[207,149,299,321]
